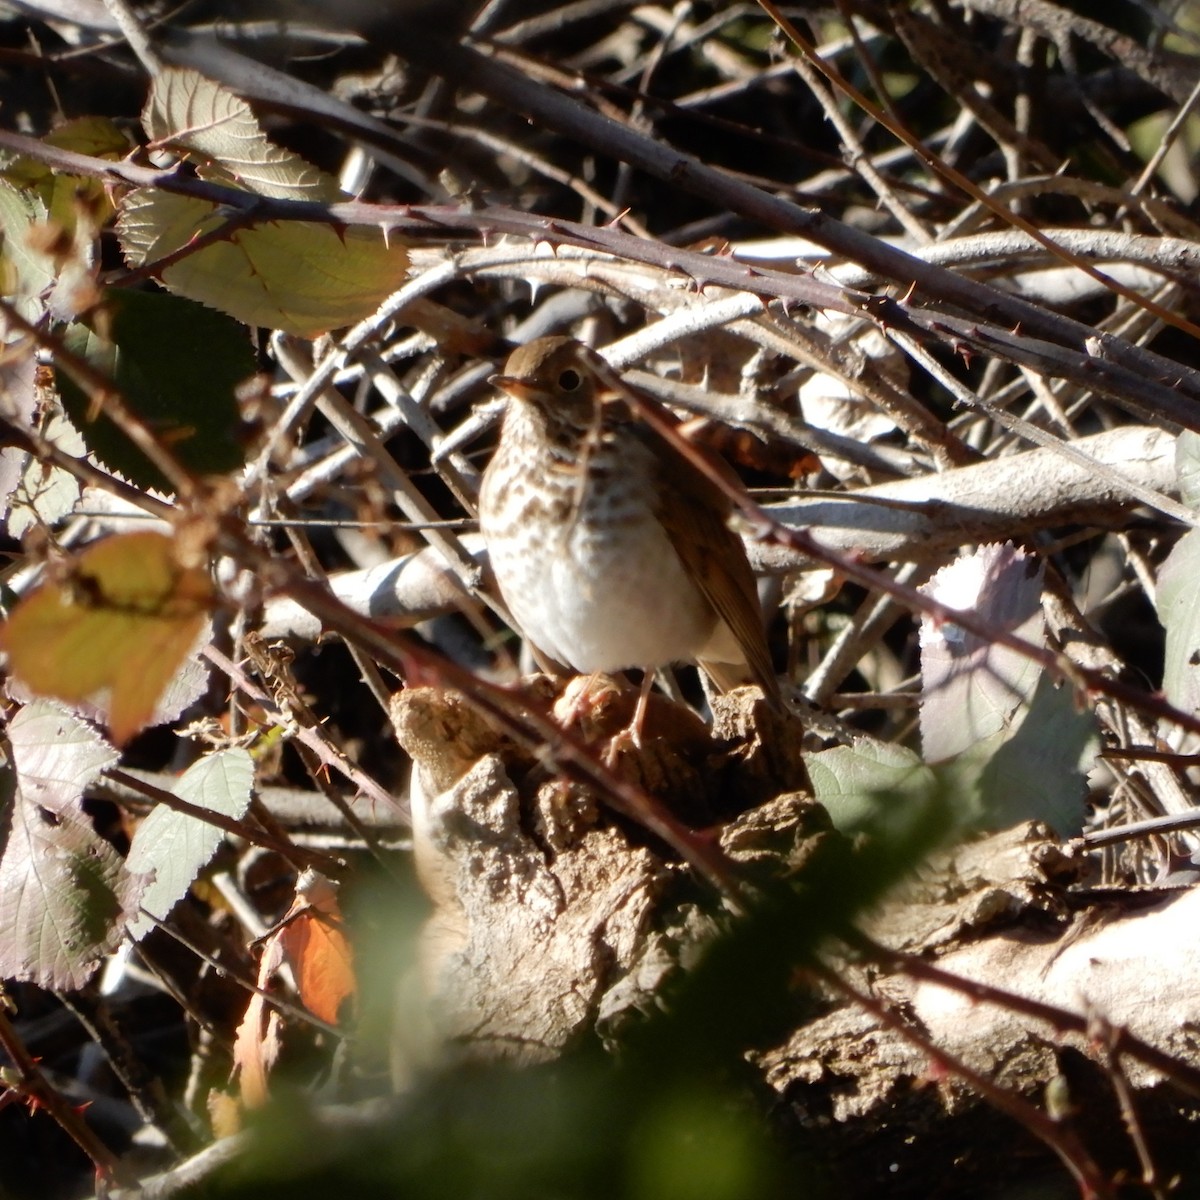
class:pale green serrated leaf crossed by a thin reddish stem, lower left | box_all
[126,750,254,938]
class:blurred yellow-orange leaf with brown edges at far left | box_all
[0,533,212,744]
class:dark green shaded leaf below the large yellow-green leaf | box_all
[59,289,254,491]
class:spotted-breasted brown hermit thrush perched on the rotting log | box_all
[479,337,779,706]
